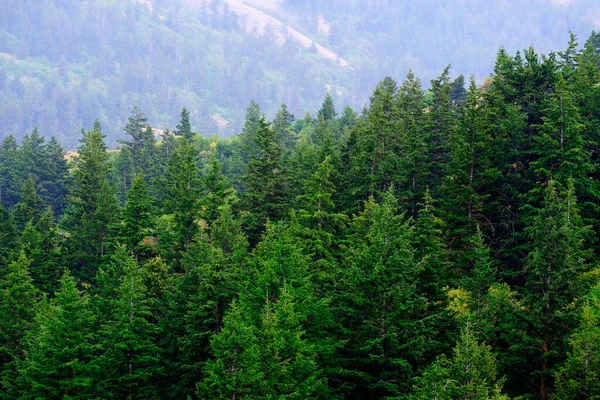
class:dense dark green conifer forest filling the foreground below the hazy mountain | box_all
[0,33,600,400]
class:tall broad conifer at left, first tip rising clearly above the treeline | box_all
[61,123,118,280]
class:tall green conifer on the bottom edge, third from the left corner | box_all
[93,247,162,399]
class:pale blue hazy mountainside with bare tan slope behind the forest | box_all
[0,0,600,148]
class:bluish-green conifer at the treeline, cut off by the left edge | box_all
[0,135,23,208]
